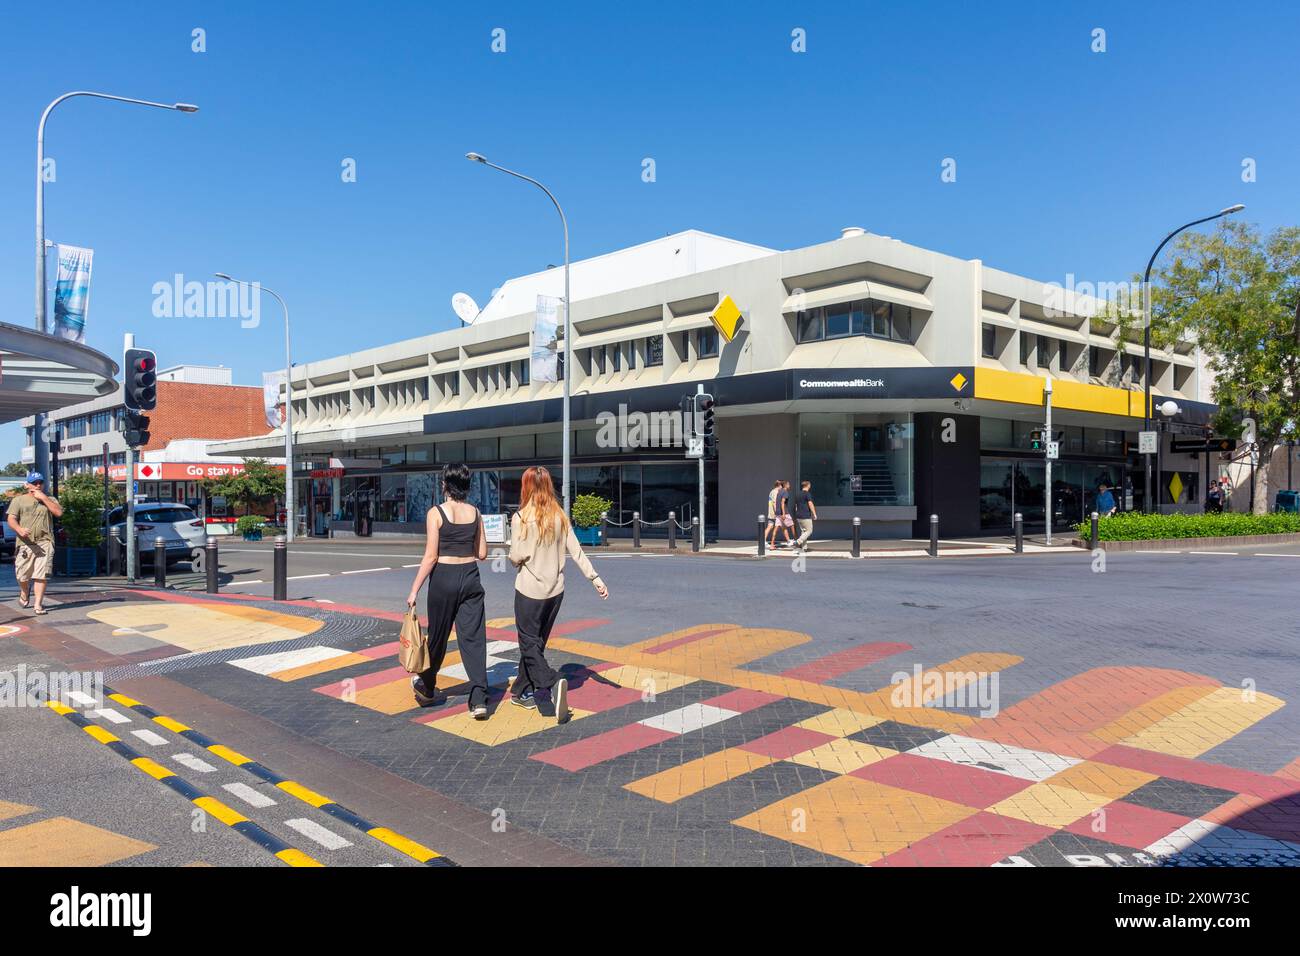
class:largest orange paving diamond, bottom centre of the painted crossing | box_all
[733,777,979,864]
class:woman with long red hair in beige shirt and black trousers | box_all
[510,464,610,723]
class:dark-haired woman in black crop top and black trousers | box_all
[407,464,488,721]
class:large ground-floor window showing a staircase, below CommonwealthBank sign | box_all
[798,412,913,507]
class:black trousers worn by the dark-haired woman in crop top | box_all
[420,561,488,708]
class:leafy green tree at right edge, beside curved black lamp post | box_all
[1152,222,1300,511]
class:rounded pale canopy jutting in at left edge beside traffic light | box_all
[0,323,117,424]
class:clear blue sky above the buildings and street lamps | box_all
[0,0,1300,460]
